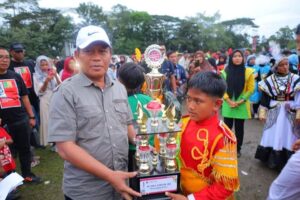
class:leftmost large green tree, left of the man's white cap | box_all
[0,6,73,58]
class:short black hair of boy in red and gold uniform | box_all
[188,71,227,98]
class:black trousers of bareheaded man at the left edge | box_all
[7,118,31,177]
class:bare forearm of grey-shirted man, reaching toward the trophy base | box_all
[56,141,113,182]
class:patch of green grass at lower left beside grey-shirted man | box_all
[17,148,64,200]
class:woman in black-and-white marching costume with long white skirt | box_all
[255,57,300,170]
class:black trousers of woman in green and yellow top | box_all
[224,117,245,152]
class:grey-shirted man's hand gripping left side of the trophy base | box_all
[109,171,141,200]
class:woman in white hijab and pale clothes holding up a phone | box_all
[33,56,61,146]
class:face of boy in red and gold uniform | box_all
[186,88,223,122]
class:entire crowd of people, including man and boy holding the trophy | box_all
[0,25,300,200]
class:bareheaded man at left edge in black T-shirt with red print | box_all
[0,47,40,182]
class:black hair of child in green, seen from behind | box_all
[118,62,145,90]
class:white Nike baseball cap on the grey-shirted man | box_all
[76,25,111,49]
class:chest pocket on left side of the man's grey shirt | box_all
[77,105,105,138]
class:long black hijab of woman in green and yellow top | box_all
[225,50,246,99]
